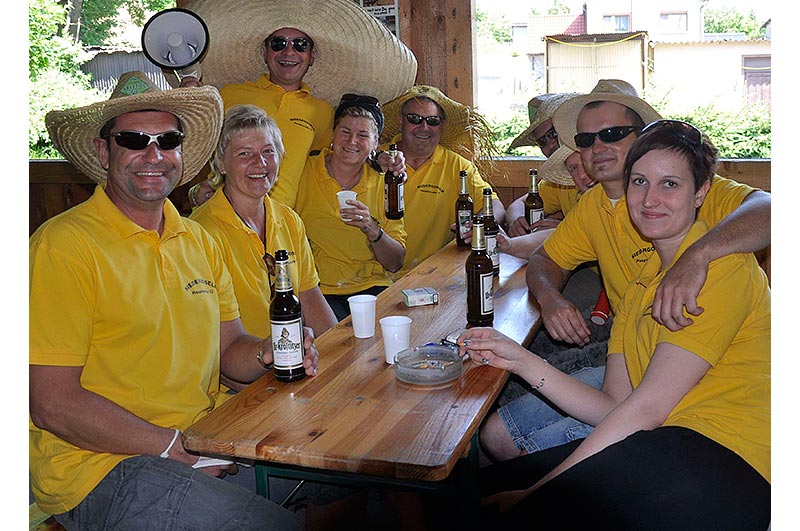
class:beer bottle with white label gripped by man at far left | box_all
[269,249,306,382]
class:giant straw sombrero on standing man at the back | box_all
[186,0,417,107]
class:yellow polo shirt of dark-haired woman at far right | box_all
[608,221,771,481]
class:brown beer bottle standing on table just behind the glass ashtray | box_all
[466,214,494,326]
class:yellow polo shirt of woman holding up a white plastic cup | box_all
[295,148,406,295]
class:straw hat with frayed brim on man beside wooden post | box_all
[381,85,497,163]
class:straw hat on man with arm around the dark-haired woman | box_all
[553,79,661,151]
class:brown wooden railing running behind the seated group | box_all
[28,157,772,234]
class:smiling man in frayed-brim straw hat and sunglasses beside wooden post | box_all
[381,85,505,277]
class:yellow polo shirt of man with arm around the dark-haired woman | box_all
[544,176,754,311]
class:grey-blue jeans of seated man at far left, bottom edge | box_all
[54,456,300,531]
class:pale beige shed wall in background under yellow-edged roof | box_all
[547,38,647,94]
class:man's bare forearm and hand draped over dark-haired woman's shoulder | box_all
[653,190,771,332]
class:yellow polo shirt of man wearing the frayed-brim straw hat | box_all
[384,144,497,278]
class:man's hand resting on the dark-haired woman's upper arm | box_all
[652,249,708,332]
